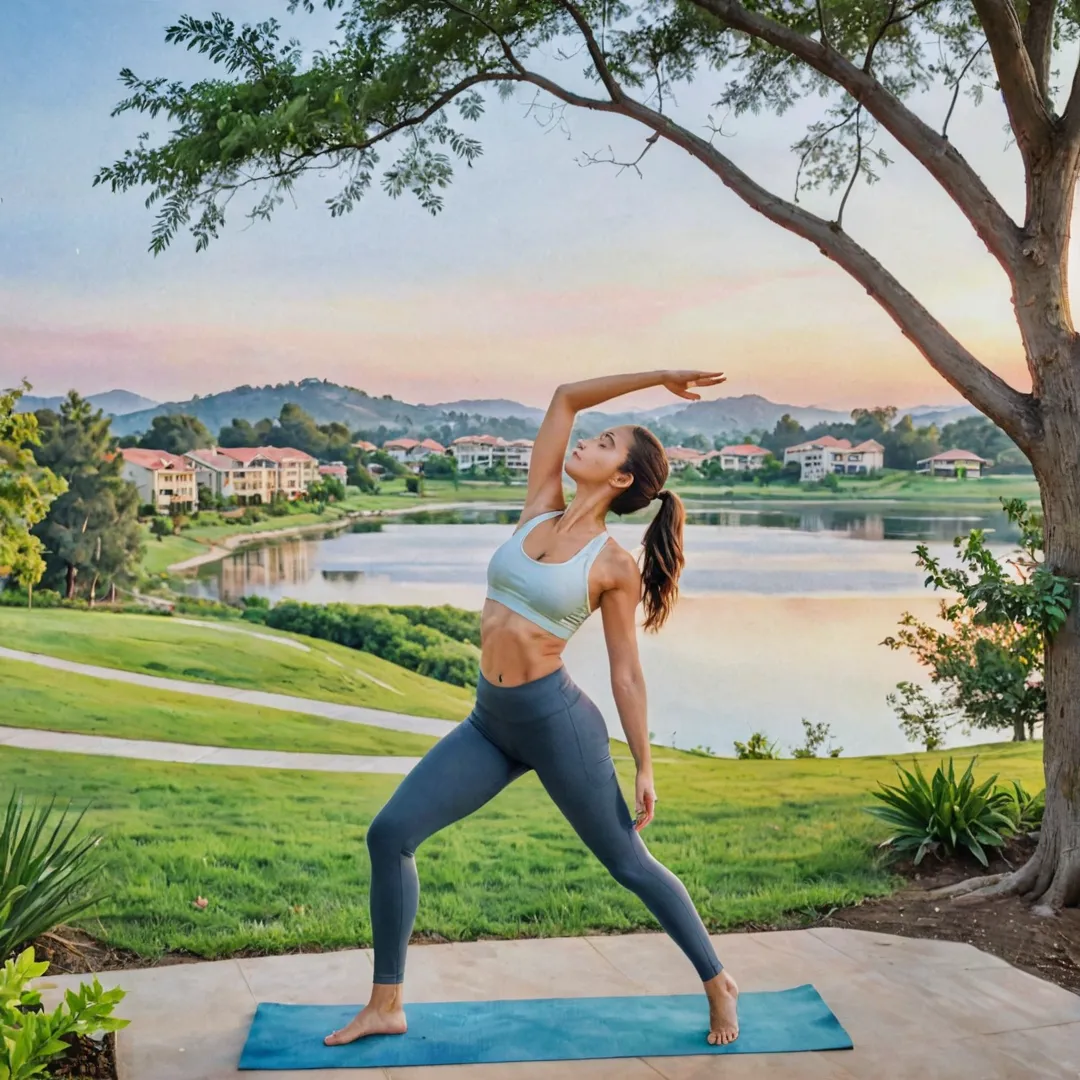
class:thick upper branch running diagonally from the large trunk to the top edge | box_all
[691,0,1023,280]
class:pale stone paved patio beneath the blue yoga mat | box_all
[35,929,1080,1080]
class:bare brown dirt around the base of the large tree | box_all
[816,841,1080,994]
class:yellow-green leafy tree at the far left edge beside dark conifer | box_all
[0,387,64,595]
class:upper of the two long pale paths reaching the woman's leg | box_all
[0,646,457,738]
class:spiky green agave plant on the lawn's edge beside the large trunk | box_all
[868,758,1015,866]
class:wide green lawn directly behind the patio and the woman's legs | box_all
[0,743,1041,957]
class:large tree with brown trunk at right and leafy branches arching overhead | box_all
[95,0,1080,910]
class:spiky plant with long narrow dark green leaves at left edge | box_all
[0,794,103,961]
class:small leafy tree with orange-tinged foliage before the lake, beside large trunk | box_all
[881,499,1070,750]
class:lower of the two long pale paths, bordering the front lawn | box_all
[0,726,420,777]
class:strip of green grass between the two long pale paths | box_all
[0,660,435,756]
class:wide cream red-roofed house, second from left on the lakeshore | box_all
[186,446,319,504]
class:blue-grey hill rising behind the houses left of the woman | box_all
[112,379,443,435]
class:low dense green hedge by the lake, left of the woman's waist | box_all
[259,600,480,686]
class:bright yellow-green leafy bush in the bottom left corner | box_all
[0,948,129,1080]
